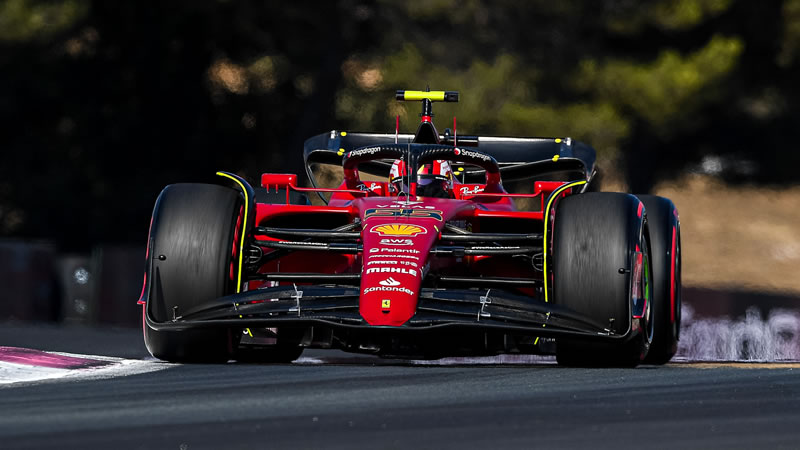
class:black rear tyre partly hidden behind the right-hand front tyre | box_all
[638,195,681,364]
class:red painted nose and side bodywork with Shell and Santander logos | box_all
[249,173,570,326]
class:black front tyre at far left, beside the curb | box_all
[143,184,243,362]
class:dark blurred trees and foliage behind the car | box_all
[0,0,800,250]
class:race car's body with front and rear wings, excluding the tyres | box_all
[140,91,620,357]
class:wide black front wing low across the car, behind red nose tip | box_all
[145,285,625,340]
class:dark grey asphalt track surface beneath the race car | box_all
[0,323,800,450]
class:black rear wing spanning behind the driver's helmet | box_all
[303,130,596,186]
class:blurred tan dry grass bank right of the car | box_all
[654,175,800,296]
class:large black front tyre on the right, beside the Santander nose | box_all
[552,192,653,367]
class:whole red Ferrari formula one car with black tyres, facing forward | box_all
[139,91,681,367]
